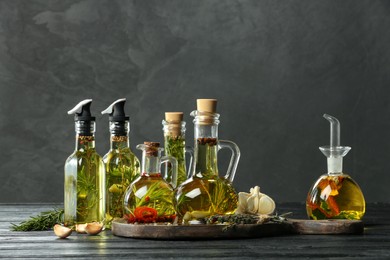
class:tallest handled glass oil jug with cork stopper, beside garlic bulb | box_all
[175,99,240,222]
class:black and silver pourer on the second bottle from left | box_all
[102,98,129,135]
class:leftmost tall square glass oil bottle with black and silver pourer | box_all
[64,99,105,233]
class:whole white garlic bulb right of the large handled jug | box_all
[236,186,275,215]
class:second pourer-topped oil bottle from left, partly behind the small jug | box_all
[102,99,140,228]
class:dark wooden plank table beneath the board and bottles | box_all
[0,203,390,259]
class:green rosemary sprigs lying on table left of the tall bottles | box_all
[11,209,64,231]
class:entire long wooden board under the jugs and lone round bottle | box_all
[112,219,364,240]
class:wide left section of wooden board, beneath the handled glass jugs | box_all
[112,217,292,240]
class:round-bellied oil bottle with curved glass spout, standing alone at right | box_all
[306,114,365,220]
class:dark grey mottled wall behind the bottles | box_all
[0,0,390,202]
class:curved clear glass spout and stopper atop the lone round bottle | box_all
[320,114,351,173]
